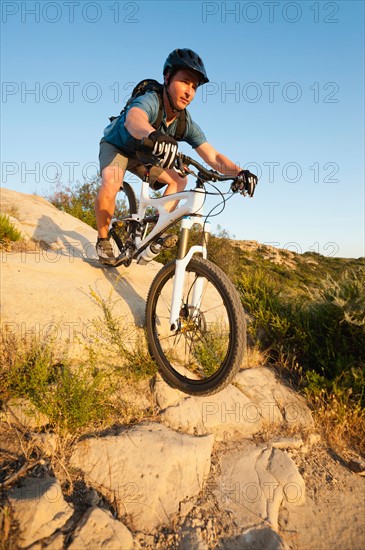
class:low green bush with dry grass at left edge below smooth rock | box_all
[0,336,117,432]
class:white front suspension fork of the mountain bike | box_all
[170,216,210,330]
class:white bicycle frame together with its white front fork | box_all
[131,181,210,330]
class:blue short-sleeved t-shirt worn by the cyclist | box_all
[104,92,207,156]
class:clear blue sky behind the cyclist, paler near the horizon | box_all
[1,0,365,257]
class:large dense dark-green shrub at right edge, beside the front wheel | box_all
[237,268,365,414]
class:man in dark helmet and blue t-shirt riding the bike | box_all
[95,49,257,266]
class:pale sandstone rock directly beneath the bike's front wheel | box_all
[155,367,313,440]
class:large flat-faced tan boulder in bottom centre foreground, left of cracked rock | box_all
[70,423,214,532]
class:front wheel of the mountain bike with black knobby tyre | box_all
[146,257,246,395]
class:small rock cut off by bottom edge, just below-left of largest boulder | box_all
[68,508,134,550]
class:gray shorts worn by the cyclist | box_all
[99,138,166,190]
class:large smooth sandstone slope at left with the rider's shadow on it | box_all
[0,189,161,362]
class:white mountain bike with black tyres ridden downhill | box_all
[109,144,252,396]
